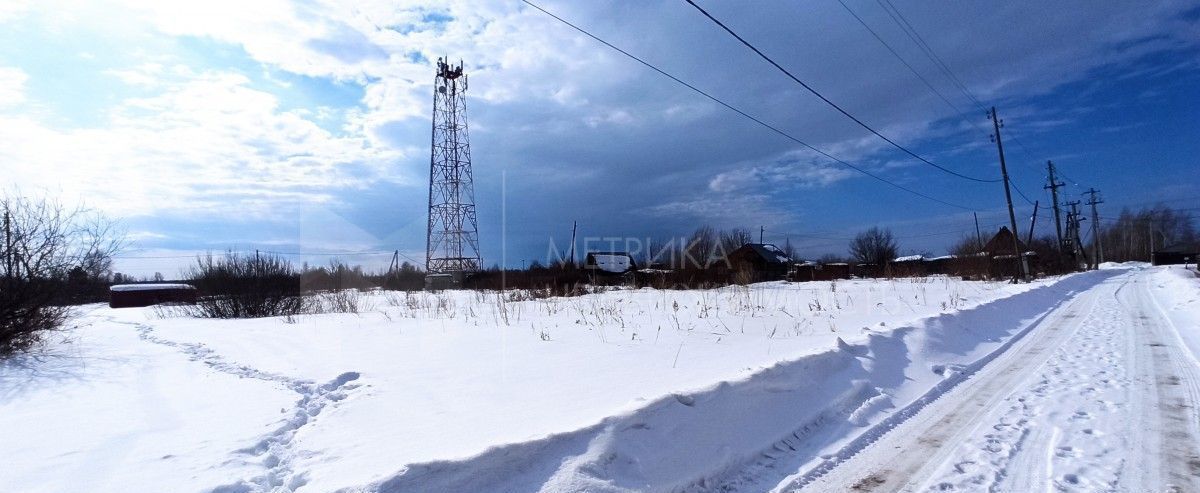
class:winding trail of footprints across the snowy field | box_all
[106,315,360,493]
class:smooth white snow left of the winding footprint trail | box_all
[0,314,295,493]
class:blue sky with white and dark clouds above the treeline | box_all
[0,0,1200,277]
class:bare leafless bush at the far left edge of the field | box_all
[0,193,125,354]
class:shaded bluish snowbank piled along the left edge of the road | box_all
[343,270,1122,493]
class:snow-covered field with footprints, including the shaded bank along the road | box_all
[0,267,1200,492]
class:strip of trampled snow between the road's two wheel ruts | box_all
[928,284,1130,492]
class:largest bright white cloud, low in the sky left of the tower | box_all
[0,72,406,217]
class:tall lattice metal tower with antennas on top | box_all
[425,59,482,275]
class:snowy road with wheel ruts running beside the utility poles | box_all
[776,270,1200,492]
